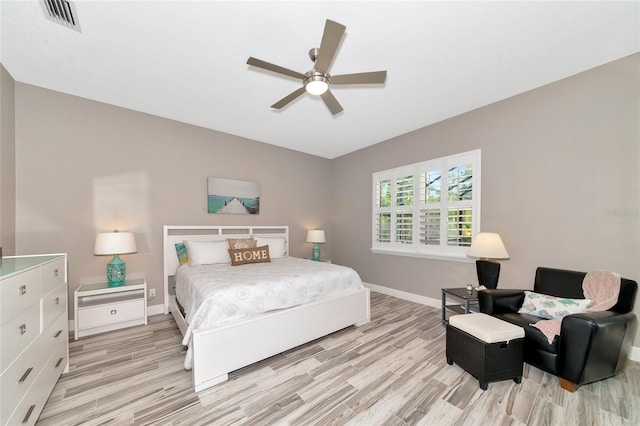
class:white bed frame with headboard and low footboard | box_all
[164,225,370,392]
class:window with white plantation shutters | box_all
[372,150,480,260]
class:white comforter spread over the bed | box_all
[176,257,362,369]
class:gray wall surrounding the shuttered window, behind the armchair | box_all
[331,54,640,345]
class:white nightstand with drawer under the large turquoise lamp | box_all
[74,279,147,340]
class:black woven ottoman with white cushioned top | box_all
[446,313,524,390]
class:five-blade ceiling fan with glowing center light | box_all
[247,19,387,115]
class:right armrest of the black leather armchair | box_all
[558,311,637,385]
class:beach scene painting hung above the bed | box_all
[207,177,260,214]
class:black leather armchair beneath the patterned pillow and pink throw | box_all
[478,267,638,392]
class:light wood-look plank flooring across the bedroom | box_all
[38,293,640,426]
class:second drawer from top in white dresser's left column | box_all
[0,303,40,372]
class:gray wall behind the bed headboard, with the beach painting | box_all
[15,83,330,318]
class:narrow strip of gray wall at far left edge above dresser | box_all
[0,64,16,256]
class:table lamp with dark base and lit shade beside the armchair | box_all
[467,232,509,288]
